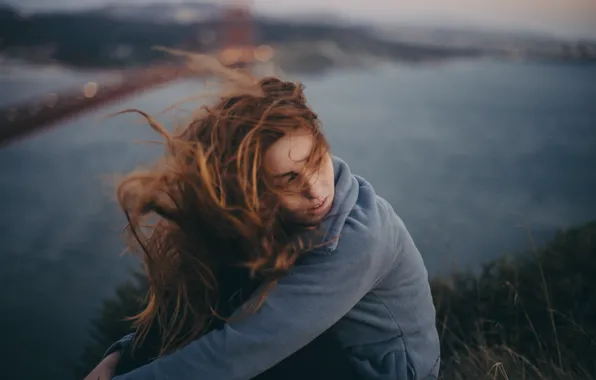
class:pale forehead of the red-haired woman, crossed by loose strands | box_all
[264,129,314,174]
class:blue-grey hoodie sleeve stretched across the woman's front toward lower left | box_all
[114,238,384,380]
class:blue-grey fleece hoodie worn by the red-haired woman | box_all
[108,158,440,380]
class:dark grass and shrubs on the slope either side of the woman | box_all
[78,222,596,380]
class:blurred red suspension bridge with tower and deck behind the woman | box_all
[0,1,255,145]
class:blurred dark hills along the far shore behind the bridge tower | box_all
[0,4,596,73]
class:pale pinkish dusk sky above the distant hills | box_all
[0,0,596,38]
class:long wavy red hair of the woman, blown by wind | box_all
[117,53,328,355]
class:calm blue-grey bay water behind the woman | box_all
[0,61,596,379]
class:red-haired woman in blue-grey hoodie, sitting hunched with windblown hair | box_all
[84,58,439,380]
